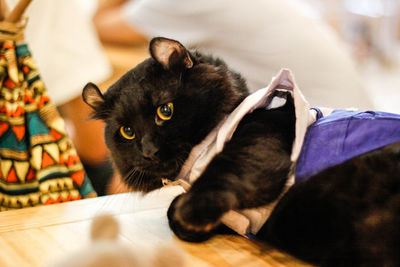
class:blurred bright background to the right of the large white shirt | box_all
[291,0,400,113]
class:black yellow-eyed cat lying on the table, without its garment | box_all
[83,38,400,266]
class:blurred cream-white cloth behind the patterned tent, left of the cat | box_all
[21,0,112,105]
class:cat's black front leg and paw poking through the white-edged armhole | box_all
[168,106,294,241]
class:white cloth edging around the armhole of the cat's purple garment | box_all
[170,69,332,235]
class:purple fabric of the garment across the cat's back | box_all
[295,110,400,182]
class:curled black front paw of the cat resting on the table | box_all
[168,193,224,242]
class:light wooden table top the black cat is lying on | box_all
[0,187,306,267]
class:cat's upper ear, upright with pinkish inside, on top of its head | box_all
[150,37,193,70]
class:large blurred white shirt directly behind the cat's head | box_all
[122,0,373,109]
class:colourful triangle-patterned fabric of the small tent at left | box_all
[0,41,96,211]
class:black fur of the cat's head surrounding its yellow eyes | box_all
[83,38,248,192]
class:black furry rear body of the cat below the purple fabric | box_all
[258,143,400,266]
